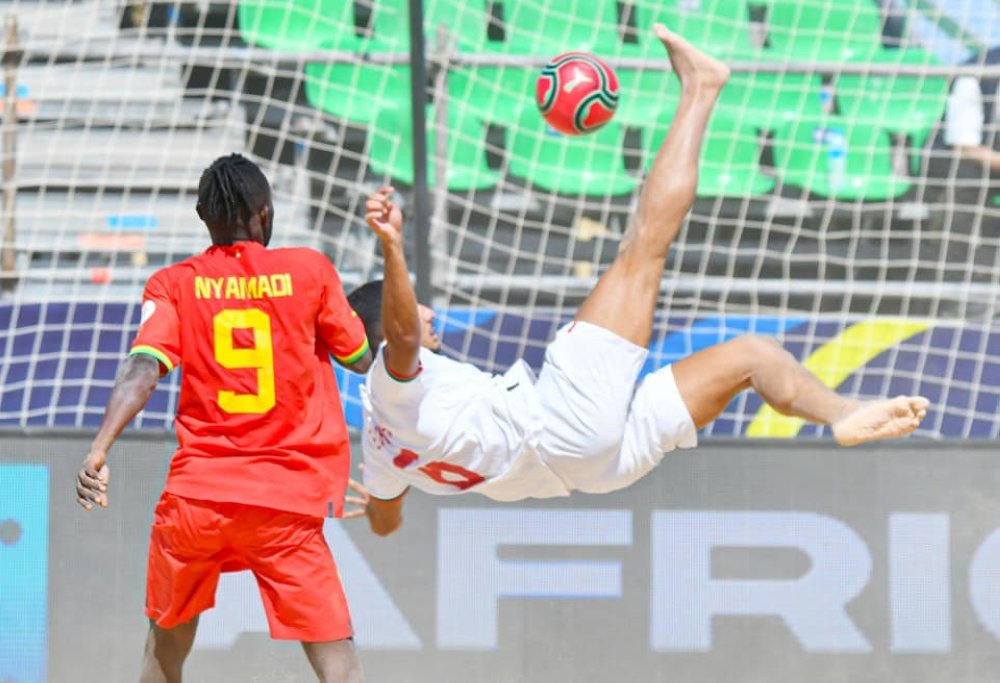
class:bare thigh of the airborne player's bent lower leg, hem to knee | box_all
[673,335,773,429]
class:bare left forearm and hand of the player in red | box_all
[76,353,160,510]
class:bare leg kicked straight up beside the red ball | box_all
[577,24,729,346]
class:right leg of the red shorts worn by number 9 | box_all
[240,508,353,642]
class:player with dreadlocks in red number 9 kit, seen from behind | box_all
[76,154,371,682]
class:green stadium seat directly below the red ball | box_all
[507,105,639,195]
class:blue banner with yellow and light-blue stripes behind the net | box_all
[0,302,1000,439]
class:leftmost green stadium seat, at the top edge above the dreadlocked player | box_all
[237,0,363,51]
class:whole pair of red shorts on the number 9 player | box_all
[146,492,353,642]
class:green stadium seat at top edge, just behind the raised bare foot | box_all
[621,0,758,60]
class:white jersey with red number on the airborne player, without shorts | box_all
[361,347,569,501]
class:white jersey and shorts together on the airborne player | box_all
[361,322,698,501]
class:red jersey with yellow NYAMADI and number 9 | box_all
[131,242,368,516]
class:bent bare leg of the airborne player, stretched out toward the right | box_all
[673,335,930,446]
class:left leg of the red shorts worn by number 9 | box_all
[146,493,225,628]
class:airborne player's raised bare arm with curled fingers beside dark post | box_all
[365,187,421,378]
